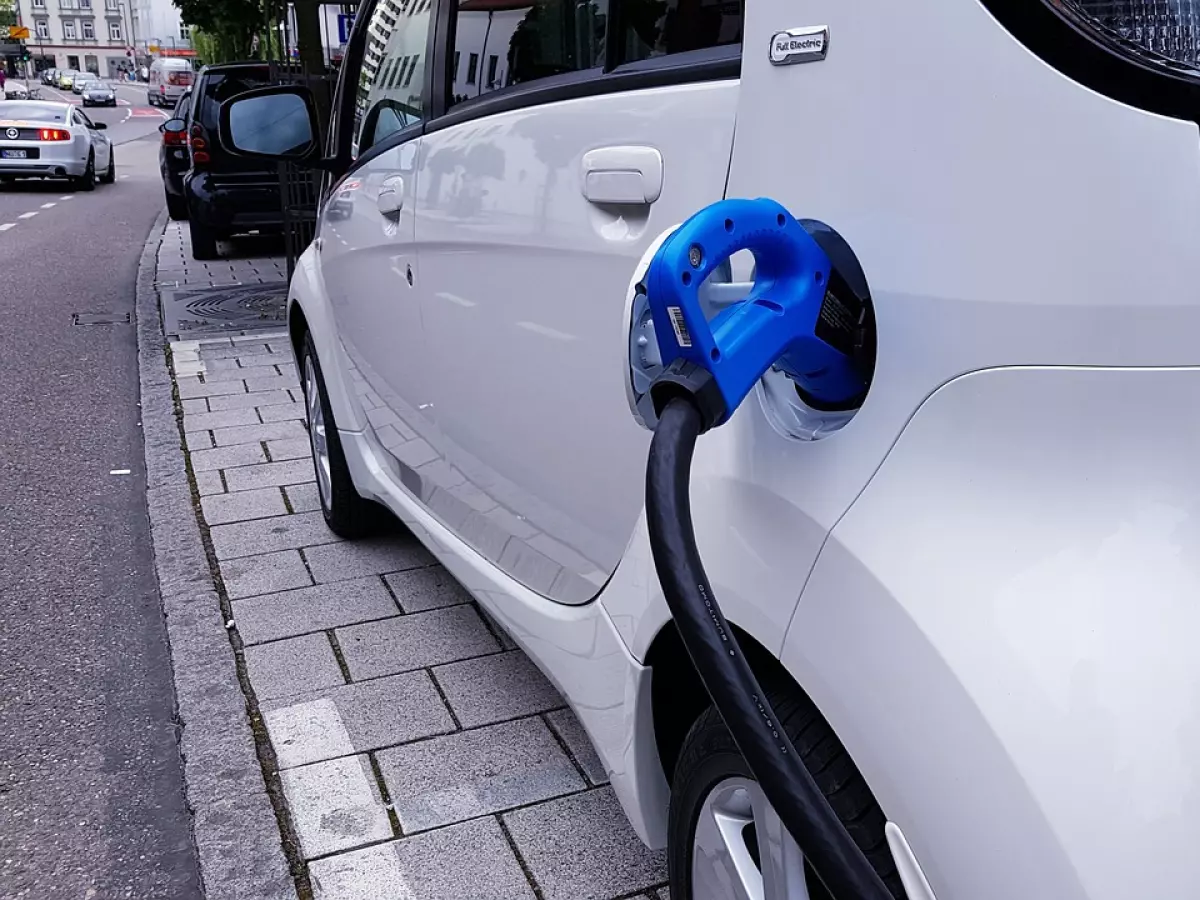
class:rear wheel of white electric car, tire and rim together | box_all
[668,691,905,900]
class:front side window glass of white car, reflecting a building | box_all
[350,0,432,157]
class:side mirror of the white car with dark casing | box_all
[218,84,319,164]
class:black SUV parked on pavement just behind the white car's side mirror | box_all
[184,62,283,259]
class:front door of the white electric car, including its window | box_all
[319,0,441,465]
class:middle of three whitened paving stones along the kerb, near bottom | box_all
[280,756,392,859]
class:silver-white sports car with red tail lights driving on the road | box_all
[0,100,116,191]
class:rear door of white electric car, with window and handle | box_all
[416,0,742,604]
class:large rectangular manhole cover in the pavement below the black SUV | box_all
[160,281,288,338]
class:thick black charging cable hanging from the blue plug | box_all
[646,396,893,900]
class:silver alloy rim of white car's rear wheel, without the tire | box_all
[691,778,815,900]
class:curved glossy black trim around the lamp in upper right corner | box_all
[980,0,1200,124]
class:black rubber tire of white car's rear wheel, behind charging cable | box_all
[668,690,905,900]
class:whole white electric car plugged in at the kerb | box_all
[222,0,1200,900]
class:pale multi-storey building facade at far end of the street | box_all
[17,0,192,78]
